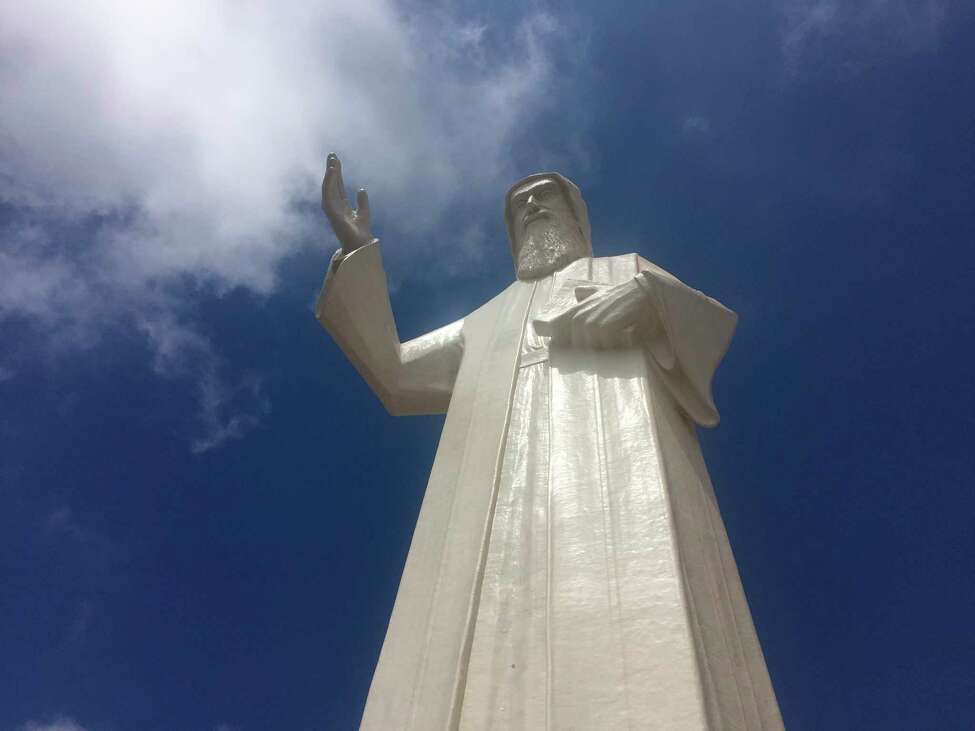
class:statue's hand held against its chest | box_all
[551,279,656,350]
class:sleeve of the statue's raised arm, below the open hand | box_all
[315,241,464,416]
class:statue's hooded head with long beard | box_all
[504,173,592,279]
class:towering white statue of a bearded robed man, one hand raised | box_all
[316,155,782,731]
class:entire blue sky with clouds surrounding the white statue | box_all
[0,0,975,731]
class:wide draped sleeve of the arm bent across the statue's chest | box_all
[637,258,738,426]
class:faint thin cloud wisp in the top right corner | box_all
[782,0,948,77]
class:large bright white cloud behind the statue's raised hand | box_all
[0,0,576,446]
